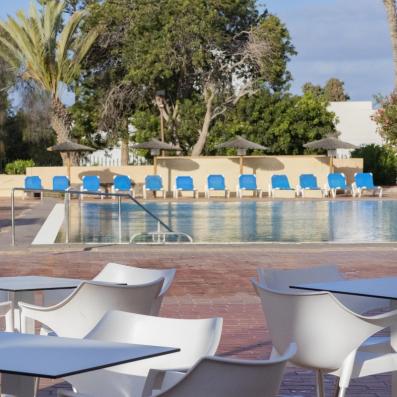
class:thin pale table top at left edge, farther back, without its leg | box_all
[0,276,83,292]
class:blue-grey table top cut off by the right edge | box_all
[290,277,397,300]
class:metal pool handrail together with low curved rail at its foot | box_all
[11,188,193,246]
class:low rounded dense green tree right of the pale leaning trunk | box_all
[210,89,335,154]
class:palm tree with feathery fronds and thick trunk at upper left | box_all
[0,0,98,162]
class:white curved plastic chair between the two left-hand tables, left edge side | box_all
[19,278,164,338]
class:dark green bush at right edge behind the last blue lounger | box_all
[352,145,397,185]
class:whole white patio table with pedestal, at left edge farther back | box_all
[0,276,83,332]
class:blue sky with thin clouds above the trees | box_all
[0,0,393,100]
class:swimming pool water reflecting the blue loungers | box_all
[56,200,397,243]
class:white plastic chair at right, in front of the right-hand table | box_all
[252,280,397,397]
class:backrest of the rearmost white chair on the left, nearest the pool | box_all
[94,263,176,315]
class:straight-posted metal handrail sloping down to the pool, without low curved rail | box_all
[11,187,174,246]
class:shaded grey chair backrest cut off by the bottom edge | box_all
[156,345,295,397]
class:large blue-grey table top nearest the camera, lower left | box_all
[0,332,180,379]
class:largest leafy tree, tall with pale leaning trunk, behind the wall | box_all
[78,0,295,158]
